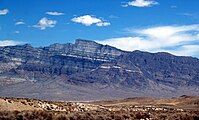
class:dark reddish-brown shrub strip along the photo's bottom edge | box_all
[0,110,199,120]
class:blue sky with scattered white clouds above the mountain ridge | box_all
[0,0,199,57]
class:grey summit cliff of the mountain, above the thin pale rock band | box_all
[44,39,123,59]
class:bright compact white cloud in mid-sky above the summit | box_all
[71,15,110,27]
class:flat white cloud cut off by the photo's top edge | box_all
[122,0,158,7]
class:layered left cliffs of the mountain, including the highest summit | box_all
[0,39,122,75]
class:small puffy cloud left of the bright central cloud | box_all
[33,17,57,30]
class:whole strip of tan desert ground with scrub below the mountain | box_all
[0,97,199,120]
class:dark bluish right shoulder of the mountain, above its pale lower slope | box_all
[67,51,199,89]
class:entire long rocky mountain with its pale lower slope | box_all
[0,39,199,100]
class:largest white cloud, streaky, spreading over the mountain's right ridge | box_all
[97,24,199,57]
